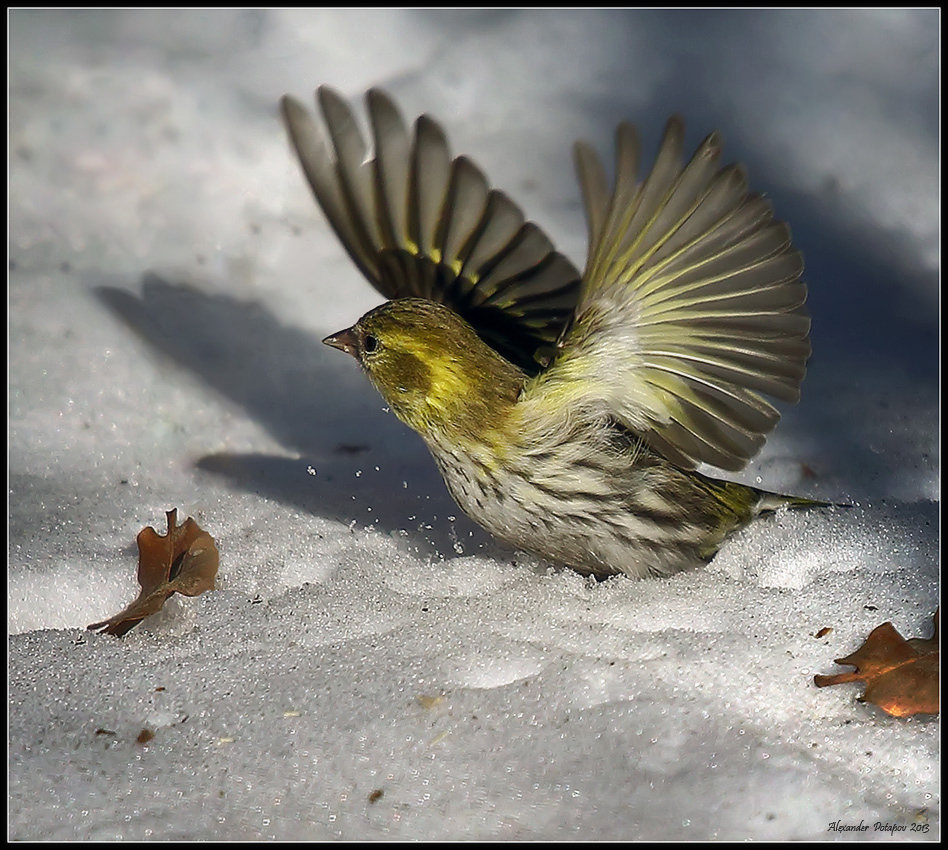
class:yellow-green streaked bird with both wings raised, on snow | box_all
[281,86,828,579]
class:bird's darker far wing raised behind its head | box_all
[282,86,580,373]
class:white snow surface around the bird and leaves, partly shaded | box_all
[8,10,940,840]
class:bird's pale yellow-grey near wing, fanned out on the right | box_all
[532,117,810,470]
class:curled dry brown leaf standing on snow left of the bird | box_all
[87,508,219,637]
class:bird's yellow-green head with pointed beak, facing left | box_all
[323,298,526,445]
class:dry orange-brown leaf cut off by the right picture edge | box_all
[813,611,939,717]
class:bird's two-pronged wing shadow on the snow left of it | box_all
[94,273,490,557]
